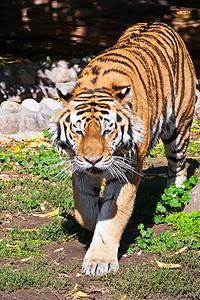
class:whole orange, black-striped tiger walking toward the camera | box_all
[50,21,196,276]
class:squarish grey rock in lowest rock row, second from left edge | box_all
[23,113,49,131]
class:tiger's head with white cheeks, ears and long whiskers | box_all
[50,66,143,180]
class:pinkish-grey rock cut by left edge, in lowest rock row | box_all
[0,115,19,134]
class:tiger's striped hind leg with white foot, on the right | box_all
[162,119,192,187]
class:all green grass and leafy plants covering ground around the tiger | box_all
[0,128,200,299]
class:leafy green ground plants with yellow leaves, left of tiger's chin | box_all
[0,141,71,184]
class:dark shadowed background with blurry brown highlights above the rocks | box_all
[0,0,200,57]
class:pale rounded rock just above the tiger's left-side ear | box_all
[52,60,71,82]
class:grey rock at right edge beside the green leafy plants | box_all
[184,180,200,214]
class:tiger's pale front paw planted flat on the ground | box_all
[82,249,119,276]
